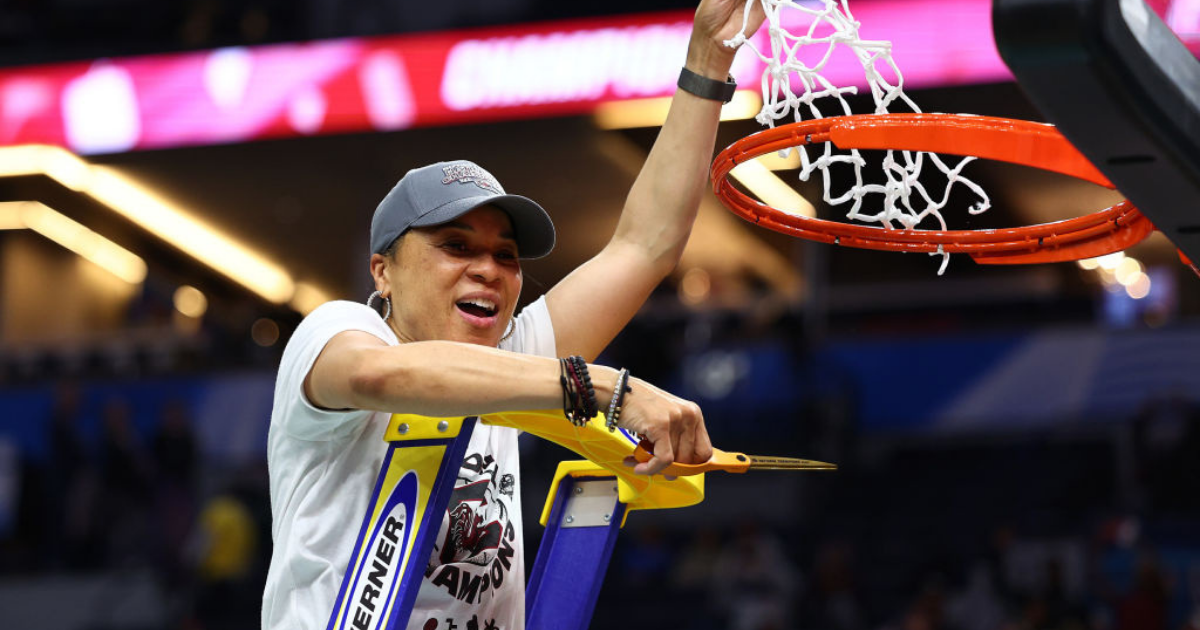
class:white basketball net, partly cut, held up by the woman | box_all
[725,0,991,274]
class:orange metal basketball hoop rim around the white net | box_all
[712,114,1154,264]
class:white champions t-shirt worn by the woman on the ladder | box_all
[263,298,556,630]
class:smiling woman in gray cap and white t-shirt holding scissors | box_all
[263,0,762,630]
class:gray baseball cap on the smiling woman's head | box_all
[371,160,554,258]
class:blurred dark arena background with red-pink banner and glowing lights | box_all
[0,0,1200,630]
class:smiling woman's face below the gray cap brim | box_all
[371,205,522,347]
